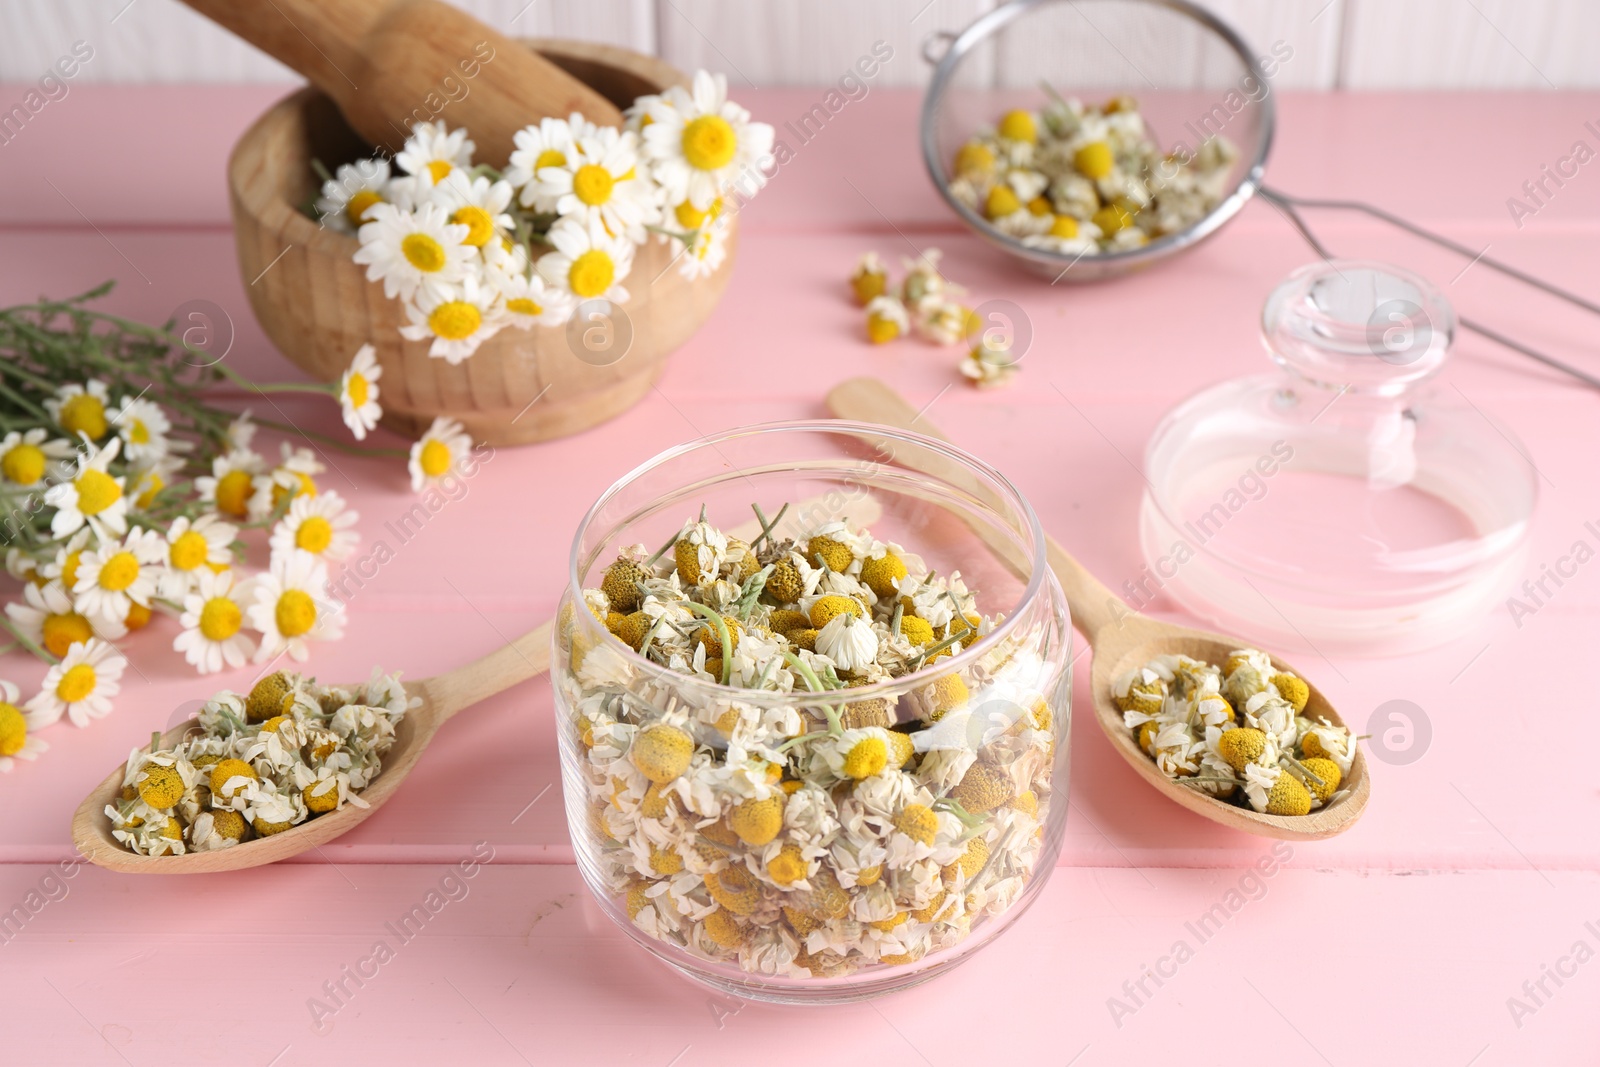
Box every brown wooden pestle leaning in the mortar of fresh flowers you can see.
[184,0,622,166]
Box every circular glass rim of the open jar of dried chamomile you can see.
[566,419,1050,707]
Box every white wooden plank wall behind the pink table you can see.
[0,0,1600,90]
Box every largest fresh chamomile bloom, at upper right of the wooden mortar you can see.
[642,70,773,211]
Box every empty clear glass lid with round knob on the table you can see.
[1122,259,1538,654]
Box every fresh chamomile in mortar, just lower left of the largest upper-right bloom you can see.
[536,126,658,242]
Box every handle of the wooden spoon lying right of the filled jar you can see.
[827,378,1136,645]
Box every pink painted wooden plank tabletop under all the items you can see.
[0,86,1600,1067]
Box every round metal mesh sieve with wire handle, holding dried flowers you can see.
[922,0,1600,387]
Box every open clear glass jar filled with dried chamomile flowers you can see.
[550,421,1072,1003]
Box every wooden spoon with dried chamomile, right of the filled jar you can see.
[827,378,1371,841]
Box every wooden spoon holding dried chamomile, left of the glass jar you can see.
[72,494,882,875]
